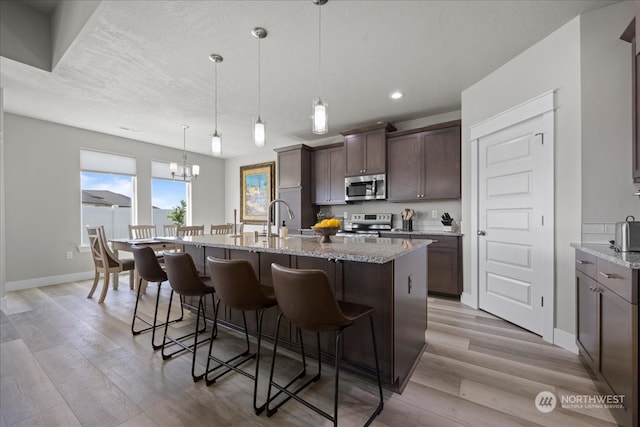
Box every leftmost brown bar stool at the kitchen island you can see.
[131,245,184,350]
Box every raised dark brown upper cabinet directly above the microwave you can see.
[342,123,396,176]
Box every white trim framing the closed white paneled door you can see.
[461,90,555,343]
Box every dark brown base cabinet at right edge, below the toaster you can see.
[576,250,640,426]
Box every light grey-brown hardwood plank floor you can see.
[0,281,615,427]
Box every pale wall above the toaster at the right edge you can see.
[580,1,640,224]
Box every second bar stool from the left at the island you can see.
[162,252,217,382]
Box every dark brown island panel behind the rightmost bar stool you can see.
[342,261,397,384]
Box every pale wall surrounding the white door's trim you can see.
[462,17,581,333]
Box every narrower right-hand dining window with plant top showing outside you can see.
[151,161,191,234]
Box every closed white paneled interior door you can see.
[477,115,554,335]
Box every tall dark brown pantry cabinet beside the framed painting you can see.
[275,145,315,233]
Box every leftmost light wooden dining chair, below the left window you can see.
[87,225,135,304]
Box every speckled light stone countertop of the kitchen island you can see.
[157,233,431,264]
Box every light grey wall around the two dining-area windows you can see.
[3,114,225,289]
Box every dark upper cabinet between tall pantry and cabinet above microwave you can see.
[311,143,346,205]
